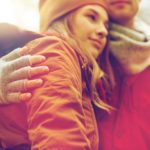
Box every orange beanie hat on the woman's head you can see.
[39,0,106,32]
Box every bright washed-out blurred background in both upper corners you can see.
[0,0,150,31]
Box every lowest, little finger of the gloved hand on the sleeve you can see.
[5,92,32,104]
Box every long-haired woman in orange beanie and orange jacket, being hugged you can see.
[0,0,112,150]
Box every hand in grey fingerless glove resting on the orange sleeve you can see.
[0,47,49,104]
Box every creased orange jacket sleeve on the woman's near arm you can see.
[27,37,90,150]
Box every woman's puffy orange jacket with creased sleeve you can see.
[0,36,99,150]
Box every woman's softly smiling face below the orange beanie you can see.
[72,5,108,58]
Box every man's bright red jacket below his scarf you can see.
[96,68,150,150]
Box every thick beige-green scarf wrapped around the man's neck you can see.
[110,18,150,74]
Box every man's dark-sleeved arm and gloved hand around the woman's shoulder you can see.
[0,23,48,104]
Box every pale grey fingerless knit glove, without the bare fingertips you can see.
[0,48,31,104]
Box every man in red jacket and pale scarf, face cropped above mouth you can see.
[96,0,150,150]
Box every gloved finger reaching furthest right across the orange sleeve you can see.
[9,66,49,81]
